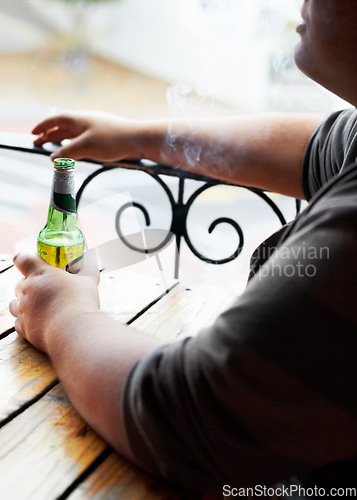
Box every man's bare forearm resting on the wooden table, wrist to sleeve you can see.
[47,311,160,460]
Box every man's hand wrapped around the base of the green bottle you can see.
[9,254,99,352]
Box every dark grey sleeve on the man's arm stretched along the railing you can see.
[303,108,357,200]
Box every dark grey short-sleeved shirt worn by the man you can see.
[123,109,357,491]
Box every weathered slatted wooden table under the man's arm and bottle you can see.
[0,256,233,500]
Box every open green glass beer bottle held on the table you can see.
[37,158,84,269]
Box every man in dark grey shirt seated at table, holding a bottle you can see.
[10,0,357,493]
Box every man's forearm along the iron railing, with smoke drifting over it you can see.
[134,114,322,198]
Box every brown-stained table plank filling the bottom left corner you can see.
[0,385,106,500]
